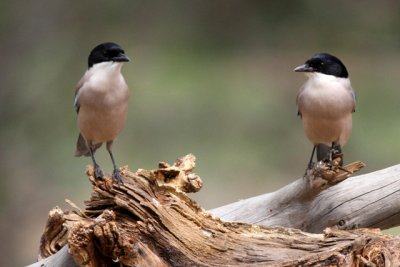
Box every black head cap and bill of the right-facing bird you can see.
[88,42,129,68]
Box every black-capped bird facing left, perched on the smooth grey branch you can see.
[294,53,356,173]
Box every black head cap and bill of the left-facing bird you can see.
[294,53,349,78]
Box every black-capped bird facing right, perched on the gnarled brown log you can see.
[74,42,130,183]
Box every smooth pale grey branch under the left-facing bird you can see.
[211,162,400,232]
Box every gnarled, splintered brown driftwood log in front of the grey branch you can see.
[31,155,400,266]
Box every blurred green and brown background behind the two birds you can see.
[0,0,400,266]
